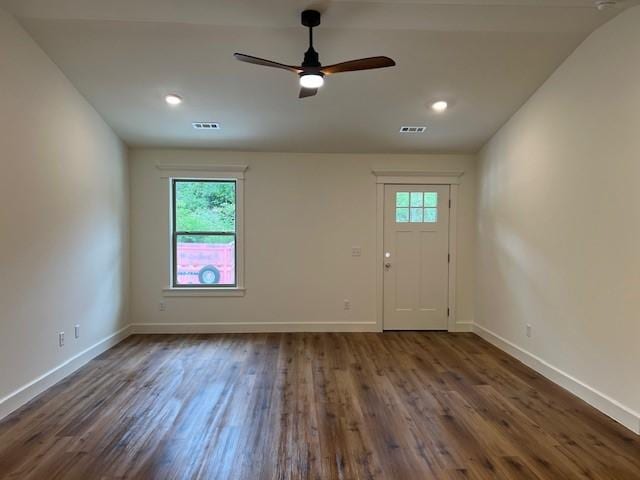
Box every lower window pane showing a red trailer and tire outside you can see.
[176,235,236,285]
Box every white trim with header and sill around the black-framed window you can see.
[156,164,248,297]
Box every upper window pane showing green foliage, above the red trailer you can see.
[175,180,236,232]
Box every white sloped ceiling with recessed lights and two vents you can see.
[0,0,635,153]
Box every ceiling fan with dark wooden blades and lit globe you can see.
[233,10,396,98]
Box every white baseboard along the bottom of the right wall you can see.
[473,324,640,435]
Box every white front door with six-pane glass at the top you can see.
[381,185,449,330]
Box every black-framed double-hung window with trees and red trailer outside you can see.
[171,179,239,288]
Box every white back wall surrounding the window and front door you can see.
[130,149,475,331]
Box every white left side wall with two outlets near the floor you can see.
[0,10,128,417]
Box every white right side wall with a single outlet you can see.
[476,7,640,431]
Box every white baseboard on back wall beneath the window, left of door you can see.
[131,322,380,334]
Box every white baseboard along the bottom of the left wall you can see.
[0,325,131,419]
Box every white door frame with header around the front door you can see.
[372,169,464,332]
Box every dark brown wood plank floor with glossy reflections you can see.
[0,333,640,480]
